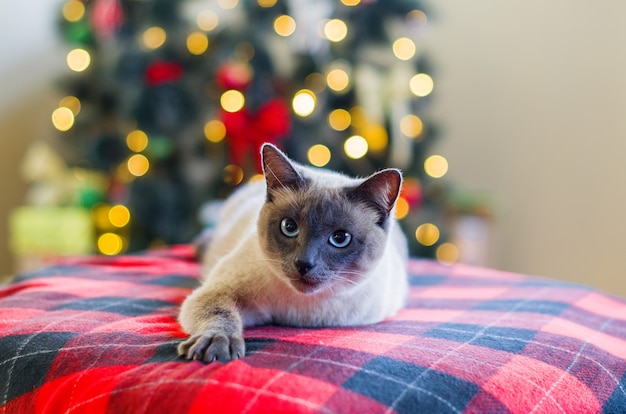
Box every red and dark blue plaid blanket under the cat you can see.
[0,246,626,413]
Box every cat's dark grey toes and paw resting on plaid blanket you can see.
[178,332,246,362]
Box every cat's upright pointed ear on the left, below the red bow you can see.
[261,143,304,195]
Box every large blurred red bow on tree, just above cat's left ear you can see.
[221,99,291,172]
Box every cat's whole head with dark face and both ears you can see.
[258,144,402,294]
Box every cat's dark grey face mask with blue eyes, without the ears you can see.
[259,186,387,294]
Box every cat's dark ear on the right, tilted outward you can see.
[350,168,402,224]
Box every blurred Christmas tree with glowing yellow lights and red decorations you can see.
[45,0,450,256]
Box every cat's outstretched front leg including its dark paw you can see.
[178,286,245,362]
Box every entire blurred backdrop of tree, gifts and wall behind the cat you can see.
[0,0,626,296]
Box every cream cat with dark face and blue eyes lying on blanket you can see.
[178,144,408,362]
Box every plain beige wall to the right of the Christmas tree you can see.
[427,0,626,296]
